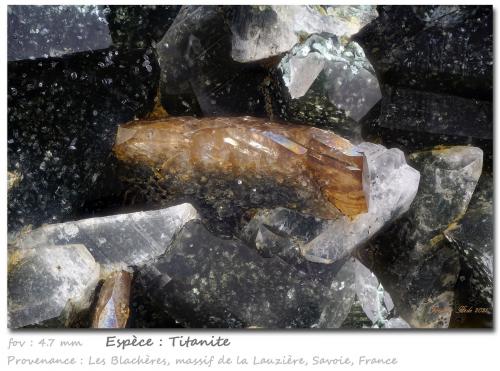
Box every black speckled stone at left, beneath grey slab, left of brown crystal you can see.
[7,49,159,230]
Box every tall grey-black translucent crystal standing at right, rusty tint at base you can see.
[360,146,483,328]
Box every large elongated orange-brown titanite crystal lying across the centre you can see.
[114,117,367,218]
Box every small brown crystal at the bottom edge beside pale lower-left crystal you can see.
[92,271,132,328]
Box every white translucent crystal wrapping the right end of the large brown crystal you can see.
[239,143,420,263]
